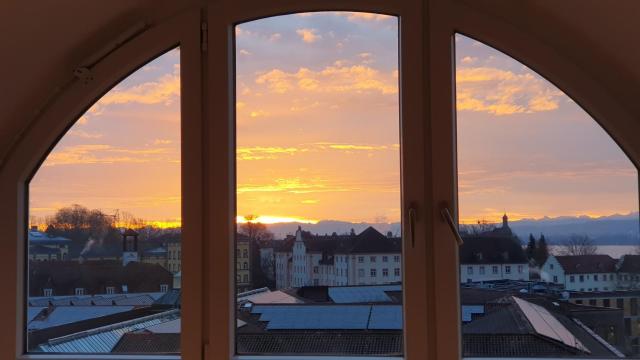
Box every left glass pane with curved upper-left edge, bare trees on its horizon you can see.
[25,49,181,354]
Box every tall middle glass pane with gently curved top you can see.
[235,12,402,355]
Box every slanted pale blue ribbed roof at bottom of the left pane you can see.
[38,310,180,353]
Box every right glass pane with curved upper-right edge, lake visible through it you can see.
[456,35,640,358]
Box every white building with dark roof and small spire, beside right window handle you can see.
[459,214,529,283]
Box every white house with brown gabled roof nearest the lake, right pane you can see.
[540,255,618,292]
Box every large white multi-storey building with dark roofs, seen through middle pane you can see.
[275,227,402,289]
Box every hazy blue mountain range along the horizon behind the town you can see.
[267,212,640,245]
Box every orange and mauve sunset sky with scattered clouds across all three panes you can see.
[30,12,638,228]
